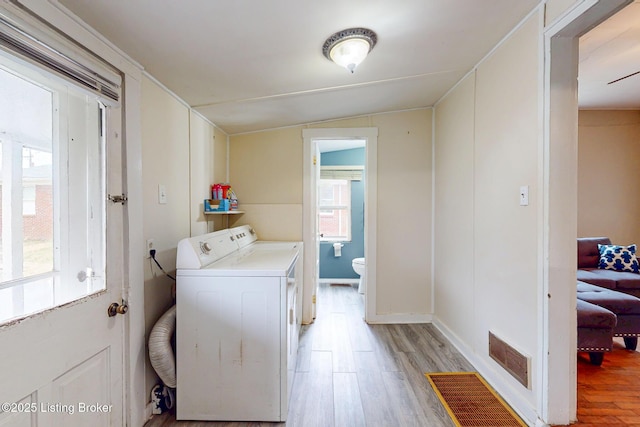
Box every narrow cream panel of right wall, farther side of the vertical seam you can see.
[434,73,476,343]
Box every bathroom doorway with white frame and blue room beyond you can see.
[302,128,378,323]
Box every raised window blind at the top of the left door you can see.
[0,10,122,102]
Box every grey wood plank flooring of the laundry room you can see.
[145,284,473,427]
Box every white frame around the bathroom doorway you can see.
[302,127,378,324]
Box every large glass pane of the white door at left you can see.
[0,59,103,322]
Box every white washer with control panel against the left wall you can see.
[176,226,303,421]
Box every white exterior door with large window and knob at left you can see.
[0,54,126,427]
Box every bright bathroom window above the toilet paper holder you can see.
[318,178,351,242]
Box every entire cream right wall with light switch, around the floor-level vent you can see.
[434,8,542,422]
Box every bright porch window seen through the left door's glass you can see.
[0,69,53,319]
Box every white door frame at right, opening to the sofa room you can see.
[537,0,631,425]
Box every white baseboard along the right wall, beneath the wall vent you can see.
[432,317,545,426]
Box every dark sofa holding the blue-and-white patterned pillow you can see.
[577,237,640,297]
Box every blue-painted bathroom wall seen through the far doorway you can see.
[319,148,365,279]
